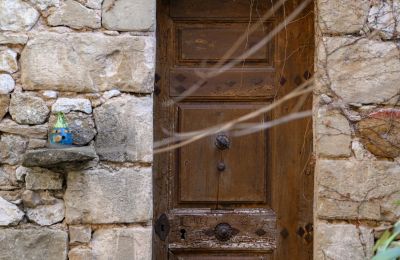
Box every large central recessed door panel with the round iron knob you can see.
[179,103,267,203]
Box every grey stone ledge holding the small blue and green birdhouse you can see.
[22,146,97,168]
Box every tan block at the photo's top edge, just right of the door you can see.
[317,0,370,34]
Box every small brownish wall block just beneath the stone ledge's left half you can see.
[25,167,63,190]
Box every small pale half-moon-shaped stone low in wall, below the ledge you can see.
[26,199,65,226]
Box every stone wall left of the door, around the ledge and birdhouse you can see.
[0,0,155,260]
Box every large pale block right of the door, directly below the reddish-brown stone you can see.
[316,160,400,221]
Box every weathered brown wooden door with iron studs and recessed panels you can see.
[153,0,314,260]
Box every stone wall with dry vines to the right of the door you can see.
[314,0,400,260]
